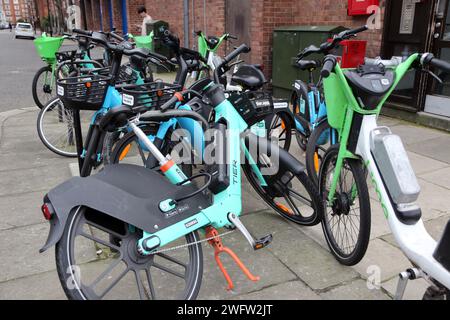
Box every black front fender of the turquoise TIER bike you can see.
[244,131,305,174]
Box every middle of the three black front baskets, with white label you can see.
[122,81,181,109]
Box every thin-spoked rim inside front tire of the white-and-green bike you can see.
[322,157,360,258]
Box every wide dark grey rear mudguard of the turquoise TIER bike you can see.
[40,164,211,252]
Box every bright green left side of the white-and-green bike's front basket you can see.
[323,73,349,131]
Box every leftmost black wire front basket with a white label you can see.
[56,74,111,110]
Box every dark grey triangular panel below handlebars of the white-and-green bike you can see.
[344,70,395,110]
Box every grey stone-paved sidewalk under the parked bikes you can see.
[0,108,450,300]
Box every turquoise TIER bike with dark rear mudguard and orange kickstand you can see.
[37,35,321,299]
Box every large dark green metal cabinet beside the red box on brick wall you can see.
[272,26,347,99]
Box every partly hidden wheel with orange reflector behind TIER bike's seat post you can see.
[109,123,193,177]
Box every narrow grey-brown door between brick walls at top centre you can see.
[225,0,252,63]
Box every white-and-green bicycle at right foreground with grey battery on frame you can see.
[319,39,450,298]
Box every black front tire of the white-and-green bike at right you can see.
[319,145,371,266]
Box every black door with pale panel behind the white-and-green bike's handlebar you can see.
[382,0,436,112]
